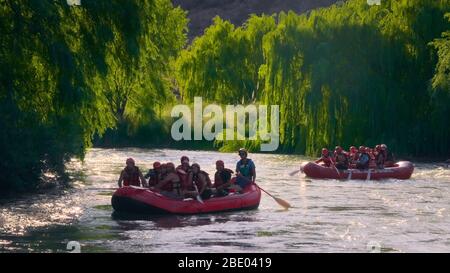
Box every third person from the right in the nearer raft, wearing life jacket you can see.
[187,163,212,199]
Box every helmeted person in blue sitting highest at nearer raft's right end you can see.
[235,148,256,192]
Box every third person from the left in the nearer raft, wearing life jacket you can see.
[150,162,184,199]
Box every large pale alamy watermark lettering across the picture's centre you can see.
[171,97,280,152]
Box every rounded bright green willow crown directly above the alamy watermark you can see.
[176,16,275,104]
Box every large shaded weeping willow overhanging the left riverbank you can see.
[0,0,186,193]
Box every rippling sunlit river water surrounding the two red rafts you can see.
[0,149,450,252]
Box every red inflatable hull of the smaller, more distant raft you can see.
[300,161,414,180]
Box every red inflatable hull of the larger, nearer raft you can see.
[111,185,261,214]
